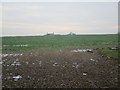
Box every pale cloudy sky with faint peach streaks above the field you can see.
[2,2,118,36]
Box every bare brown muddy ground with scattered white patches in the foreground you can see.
[2,50,119,88]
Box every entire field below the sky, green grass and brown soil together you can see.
[2,34,120,88]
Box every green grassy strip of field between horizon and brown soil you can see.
[2,35,118,52]
